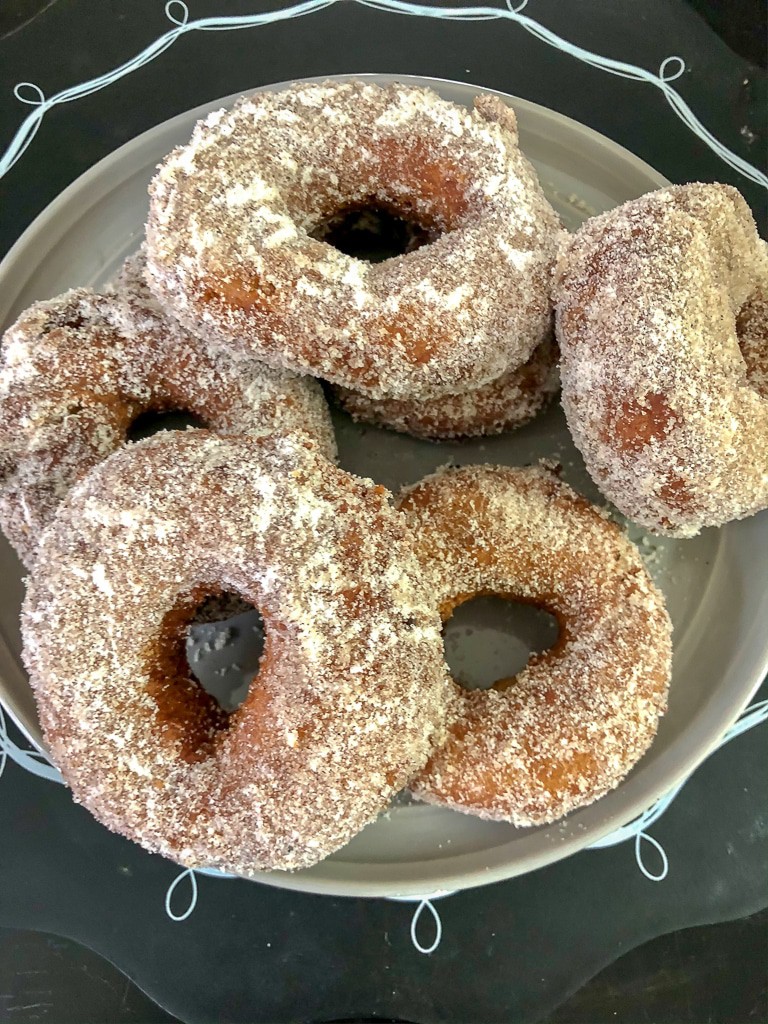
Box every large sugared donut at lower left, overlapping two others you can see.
[23,430,446,876]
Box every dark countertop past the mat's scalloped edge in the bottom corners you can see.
[6,910,768,1024]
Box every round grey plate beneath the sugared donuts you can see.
[0,75,768,896]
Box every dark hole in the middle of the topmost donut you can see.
[309,199,442,263]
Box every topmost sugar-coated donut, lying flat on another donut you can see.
[146,81,560,399]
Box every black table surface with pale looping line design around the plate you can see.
[0,0,768,1024]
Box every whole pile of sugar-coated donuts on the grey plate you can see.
[0,82,768,876]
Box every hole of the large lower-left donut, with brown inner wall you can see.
[148,588,265,762]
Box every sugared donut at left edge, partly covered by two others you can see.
[0,257,336,567]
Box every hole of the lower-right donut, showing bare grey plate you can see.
[442,595,560,690]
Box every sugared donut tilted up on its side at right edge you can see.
[555,184,768,537]
